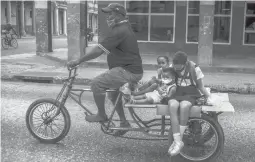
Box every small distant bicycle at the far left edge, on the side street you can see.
[1,30,18,49]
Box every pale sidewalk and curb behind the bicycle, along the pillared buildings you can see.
[1,34,255,94]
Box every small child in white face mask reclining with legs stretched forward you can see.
[130,67,176,104]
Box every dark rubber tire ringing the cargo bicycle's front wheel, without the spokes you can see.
[26,98,71,144]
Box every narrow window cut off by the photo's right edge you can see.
[244,2,255,45]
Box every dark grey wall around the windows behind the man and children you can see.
[95,1,255,57]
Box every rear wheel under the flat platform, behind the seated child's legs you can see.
[169,114,224,162]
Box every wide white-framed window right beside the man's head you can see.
[125,0,175,43]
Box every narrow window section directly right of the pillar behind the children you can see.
[213,1,232,44]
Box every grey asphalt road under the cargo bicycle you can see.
[1,82,255,162]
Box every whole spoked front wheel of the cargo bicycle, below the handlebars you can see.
[26,98,71,144]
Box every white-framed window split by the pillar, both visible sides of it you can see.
[186,1,232,44]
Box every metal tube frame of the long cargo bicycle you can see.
[48,67,170,140]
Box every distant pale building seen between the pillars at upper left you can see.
[1,0,98,36]
